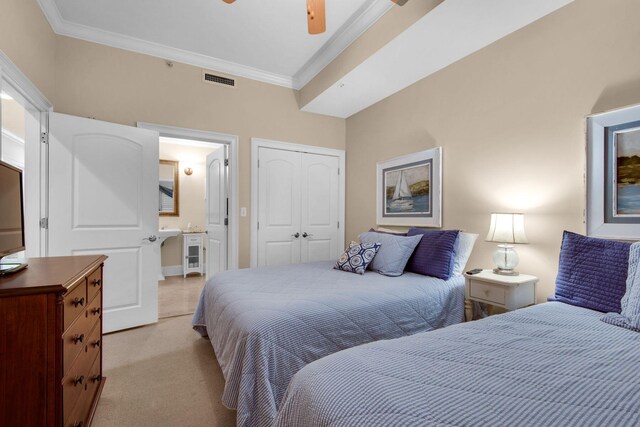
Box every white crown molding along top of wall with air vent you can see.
[37,0,293,88]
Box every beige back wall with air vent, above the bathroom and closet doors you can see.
[54,37,345,267]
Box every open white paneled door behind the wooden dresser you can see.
[49,113,160,332]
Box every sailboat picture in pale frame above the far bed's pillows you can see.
[376,147,442,227]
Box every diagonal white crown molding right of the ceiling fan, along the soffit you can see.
[293,0,394,90]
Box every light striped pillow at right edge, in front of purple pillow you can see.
[602,243,640,332]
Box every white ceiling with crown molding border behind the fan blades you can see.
[38,0,393,88]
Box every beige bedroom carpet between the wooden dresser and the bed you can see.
[93,316,235,427]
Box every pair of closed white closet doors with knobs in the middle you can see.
[257,147,342,267]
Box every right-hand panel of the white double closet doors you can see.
[300,153,342,262]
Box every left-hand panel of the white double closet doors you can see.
[258,147,301,267]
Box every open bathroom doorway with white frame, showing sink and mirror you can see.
[138,123,238,318]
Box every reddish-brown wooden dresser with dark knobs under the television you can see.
[0,255,107,427]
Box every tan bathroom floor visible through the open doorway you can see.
[158,275,205,319]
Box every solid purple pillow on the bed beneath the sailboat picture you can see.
[405,228,460,280]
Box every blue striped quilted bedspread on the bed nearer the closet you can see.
[193,262,464,426]
